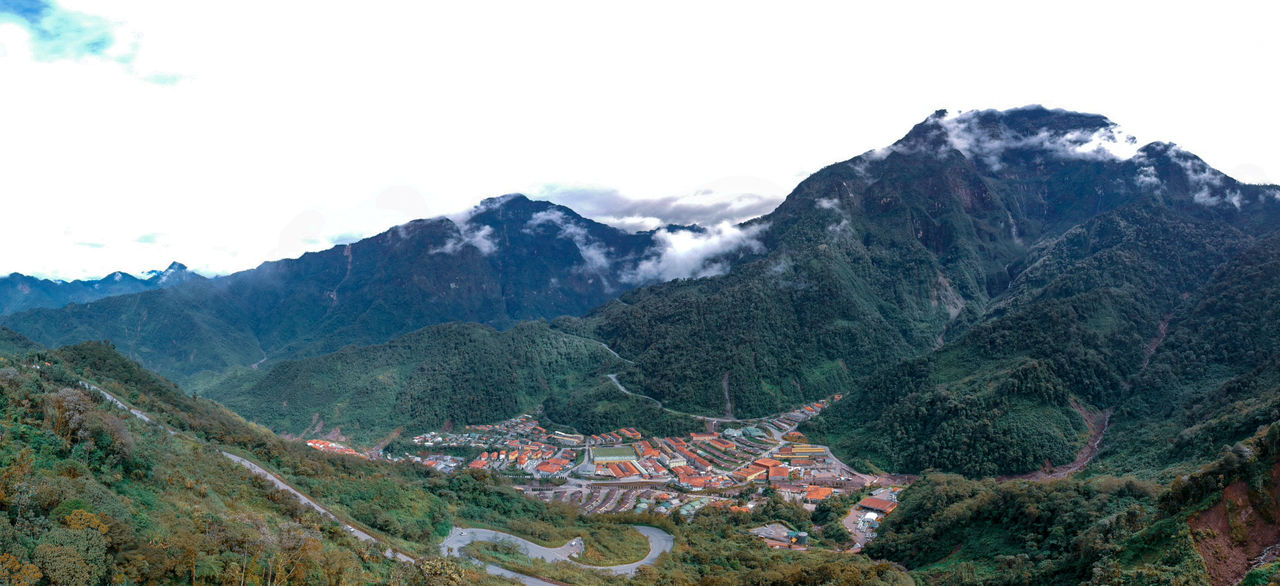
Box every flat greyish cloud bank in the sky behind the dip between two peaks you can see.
[538,184,782,232]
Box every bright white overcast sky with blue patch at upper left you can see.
[0,0,1280,279]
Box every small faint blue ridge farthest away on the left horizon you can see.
[0,262,204,315]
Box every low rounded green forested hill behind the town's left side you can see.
[207,322,701,443]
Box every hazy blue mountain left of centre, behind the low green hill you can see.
[0,194,750,380]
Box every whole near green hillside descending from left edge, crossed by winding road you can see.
[0,343,913,586]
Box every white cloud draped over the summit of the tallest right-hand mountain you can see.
[931,106,1140,170]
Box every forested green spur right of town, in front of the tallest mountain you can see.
[808,202,1249,476]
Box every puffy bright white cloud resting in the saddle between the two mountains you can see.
[622,221,768,283]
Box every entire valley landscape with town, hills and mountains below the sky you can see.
[0,106,1280,585]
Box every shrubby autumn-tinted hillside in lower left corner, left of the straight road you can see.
[0,347,488,585]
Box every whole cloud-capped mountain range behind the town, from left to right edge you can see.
[0,107,1280,476]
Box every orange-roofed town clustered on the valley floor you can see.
[307,394,910,553]
